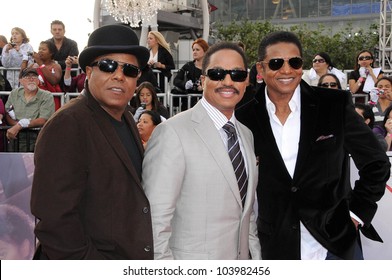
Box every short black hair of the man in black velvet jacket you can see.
[258,31,302,61]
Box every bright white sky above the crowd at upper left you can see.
[0,0,95,51]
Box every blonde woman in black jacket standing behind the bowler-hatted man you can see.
[147,31,175,92]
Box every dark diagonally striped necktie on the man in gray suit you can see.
[223,122,248,206]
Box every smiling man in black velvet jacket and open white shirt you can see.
[236,31,390,259]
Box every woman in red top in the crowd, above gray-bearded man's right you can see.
[22,40,63,111]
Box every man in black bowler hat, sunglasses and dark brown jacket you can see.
[31,25,153,259]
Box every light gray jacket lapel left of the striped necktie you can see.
[192,102,242,207]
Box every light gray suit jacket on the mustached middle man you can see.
[142,102,260,259]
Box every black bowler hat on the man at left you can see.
[79,24,150,72]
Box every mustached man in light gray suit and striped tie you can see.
[142,43,260,259]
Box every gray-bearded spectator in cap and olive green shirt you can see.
[5,68,54,152]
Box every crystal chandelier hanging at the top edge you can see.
[105,0,161,27]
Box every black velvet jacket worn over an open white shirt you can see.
[236,81,390,259]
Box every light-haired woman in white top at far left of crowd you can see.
[1,27,34,89]
